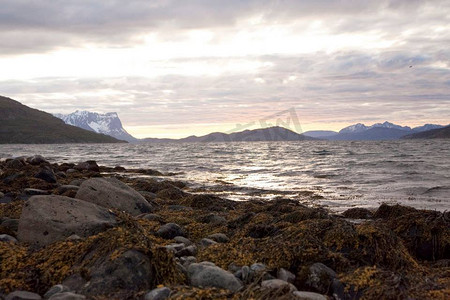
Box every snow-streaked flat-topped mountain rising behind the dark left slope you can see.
[54,110,137,142]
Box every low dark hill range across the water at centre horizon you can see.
[141,126,314,143]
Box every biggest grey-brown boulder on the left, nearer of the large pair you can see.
[17,195,117,246]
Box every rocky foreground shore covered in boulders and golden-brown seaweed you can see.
[0,155,450,300]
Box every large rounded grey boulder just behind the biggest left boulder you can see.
[75,178,152,216]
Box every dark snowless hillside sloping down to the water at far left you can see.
[0,96,123,144]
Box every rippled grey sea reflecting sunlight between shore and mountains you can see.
[0,140,450,212]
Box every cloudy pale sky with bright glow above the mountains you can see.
[0,0,450,138]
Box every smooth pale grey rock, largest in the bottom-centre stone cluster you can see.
[188,262,242,292]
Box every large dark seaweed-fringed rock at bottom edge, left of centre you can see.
[80,250,155,298]
